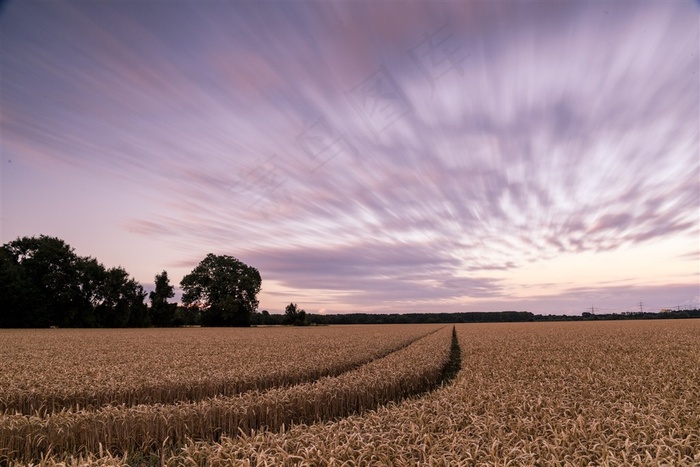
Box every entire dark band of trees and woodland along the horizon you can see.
[0,235,700,328]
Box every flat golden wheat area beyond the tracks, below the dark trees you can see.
[0,325,438,416]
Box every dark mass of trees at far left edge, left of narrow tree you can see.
[0,235,149,327]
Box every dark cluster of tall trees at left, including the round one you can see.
[0,235,261,328]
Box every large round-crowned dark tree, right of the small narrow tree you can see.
[180,253,262,326]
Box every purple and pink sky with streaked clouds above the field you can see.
[0,0,700,314]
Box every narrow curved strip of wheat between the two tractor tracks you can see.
[0,327,457,462]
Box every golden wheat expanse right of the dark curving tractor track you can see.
[167,320,700,466]
